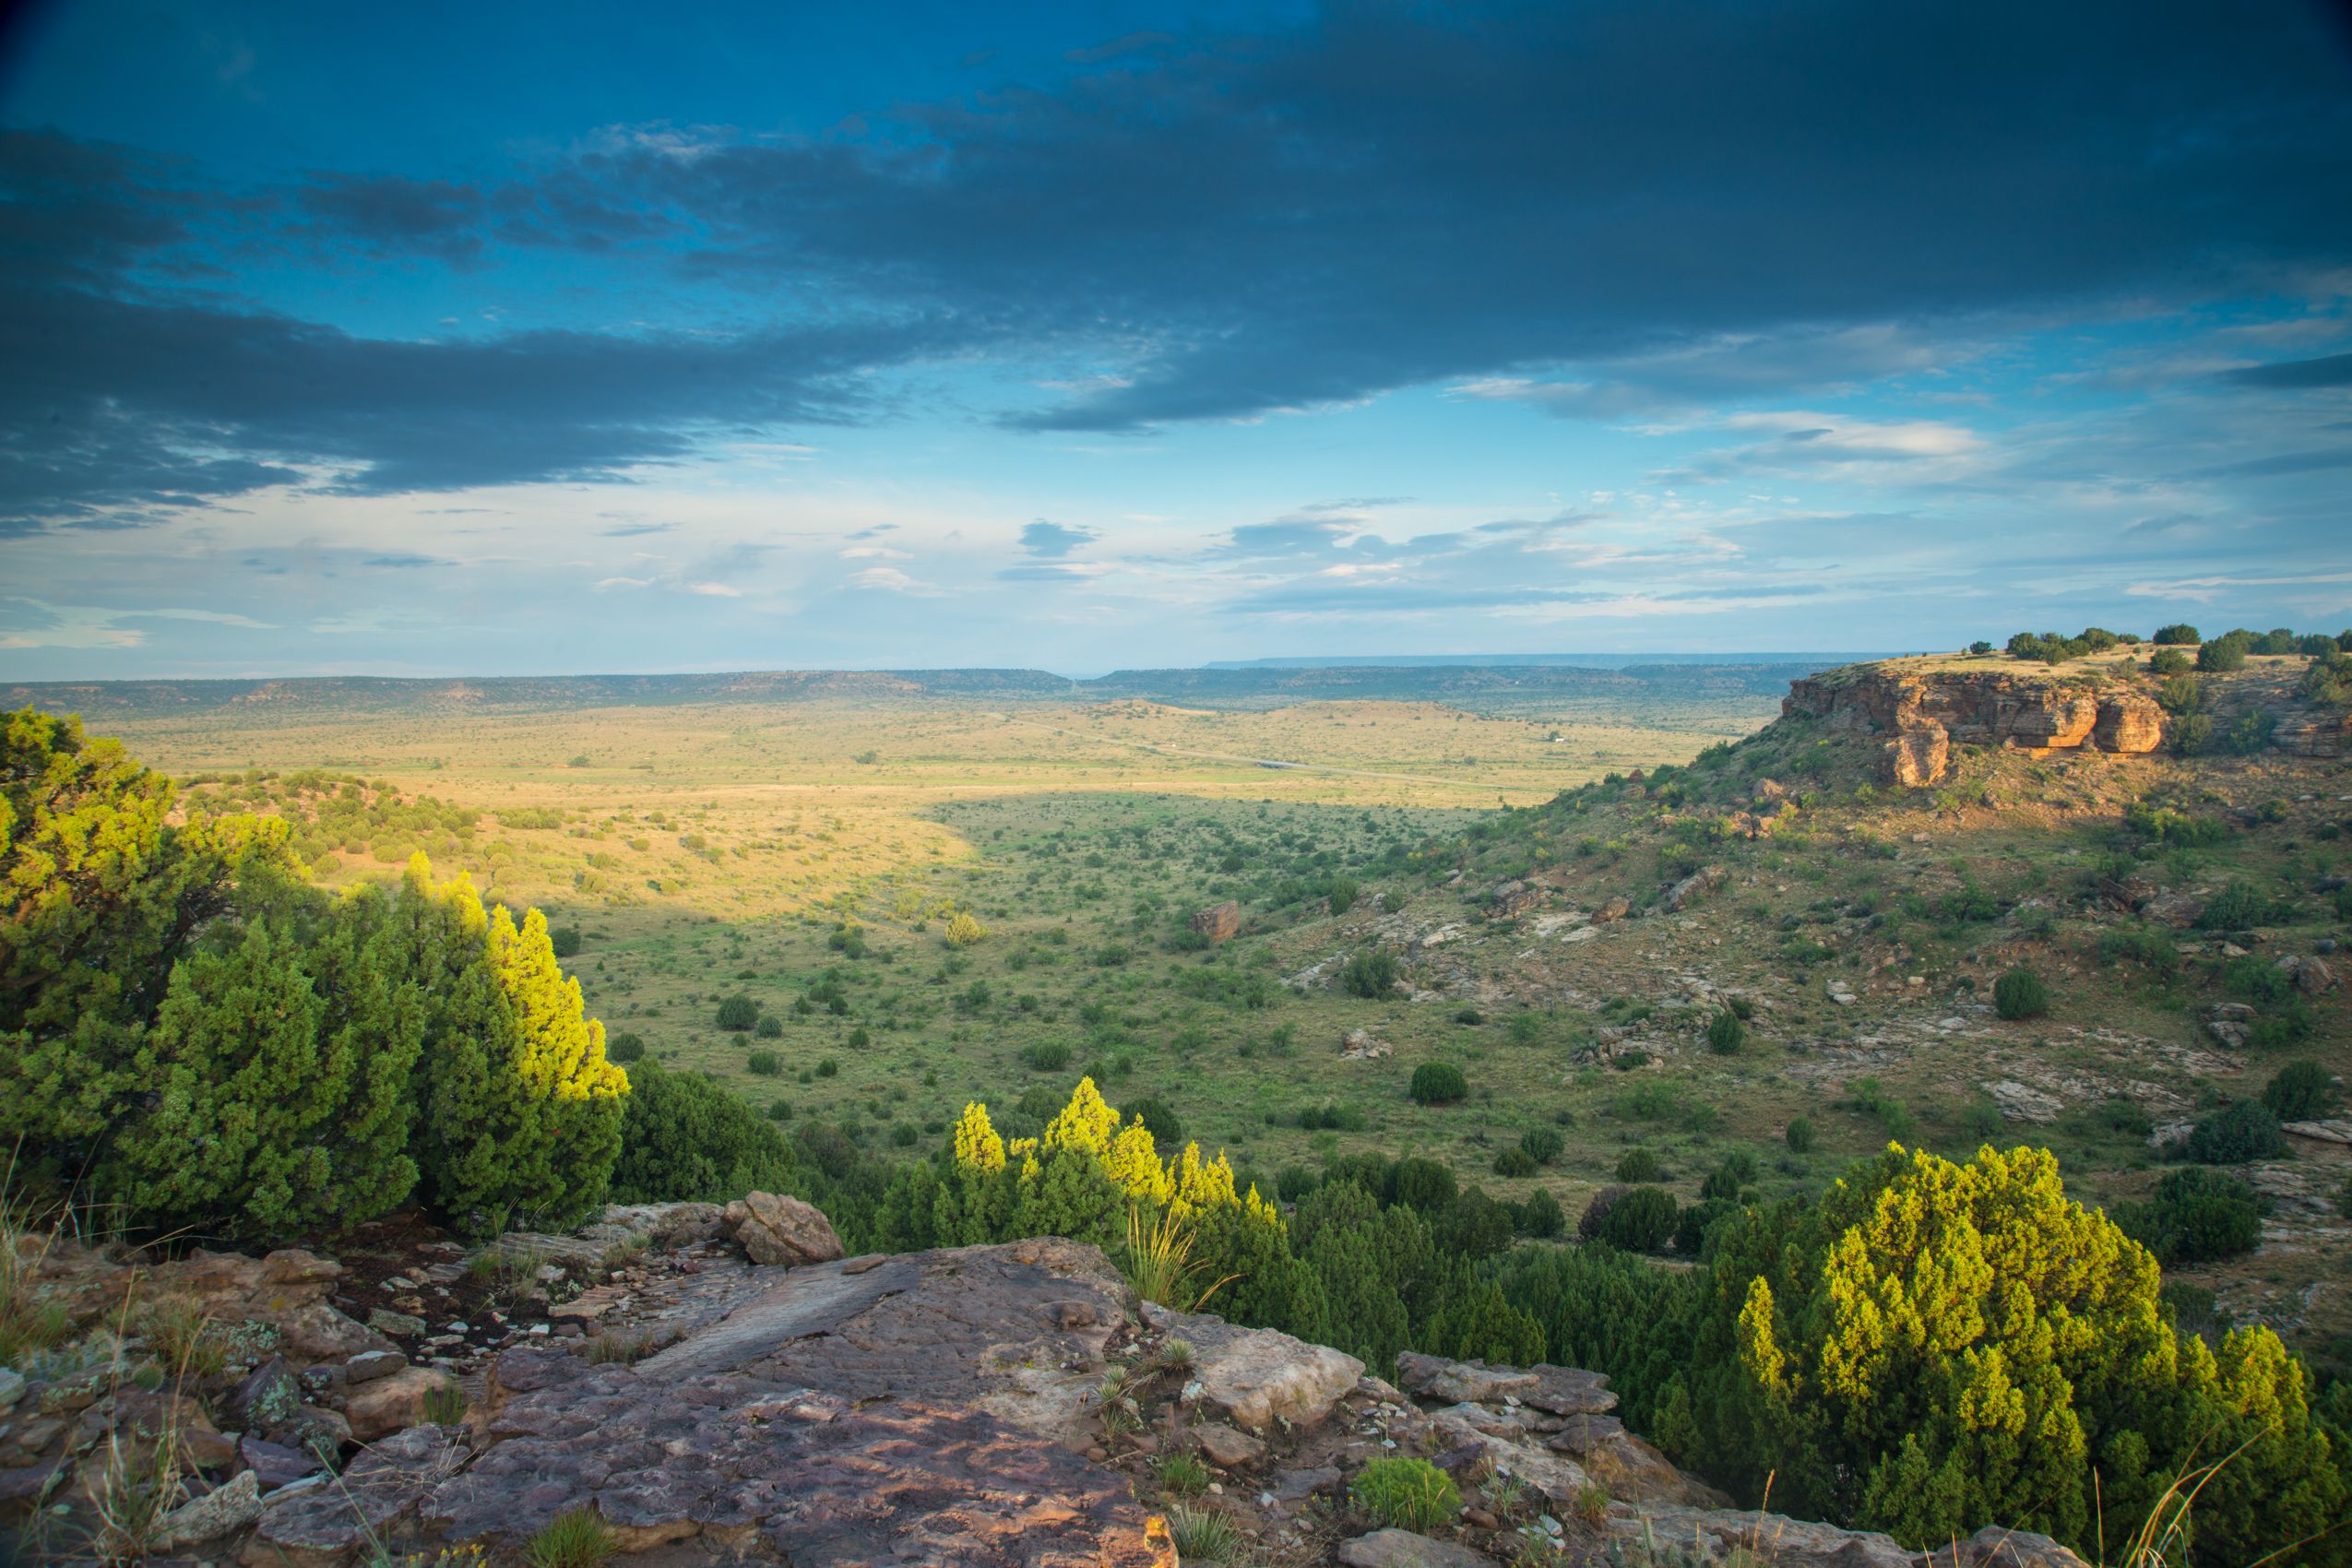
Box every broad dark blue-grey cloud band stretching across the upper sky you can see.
[0,0,2352,531]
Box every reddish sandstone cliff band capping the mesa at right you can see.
[1780,665,2164,785]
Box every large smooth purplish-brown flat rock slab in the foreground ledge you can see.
[324,1239,1176,1568]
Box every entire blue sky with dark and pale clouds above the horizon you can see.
[0,0,2352,680]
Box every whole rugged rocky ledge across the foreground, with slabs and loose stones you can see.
[0,1199,2079,1568]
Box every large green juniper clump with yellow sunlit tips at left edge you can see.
[0,710,628,1239]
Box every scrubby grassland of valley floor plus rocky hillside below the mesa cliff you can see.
[64,654,2352,1363]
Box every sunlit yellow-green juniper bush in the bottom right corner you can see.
[1654,1149,2345,1563]
